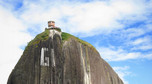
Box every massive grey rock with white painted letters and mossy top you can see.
[7,29,123,84]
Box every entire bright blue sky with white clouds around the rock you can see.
[0,0,152,84]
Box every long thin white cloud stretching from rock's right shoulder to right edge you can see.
[97,46,152,61]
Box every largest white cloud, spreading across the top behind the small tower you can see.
[17,0,150,37]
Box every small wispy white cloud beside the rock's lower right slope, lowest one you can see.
[112,66,131,84]
